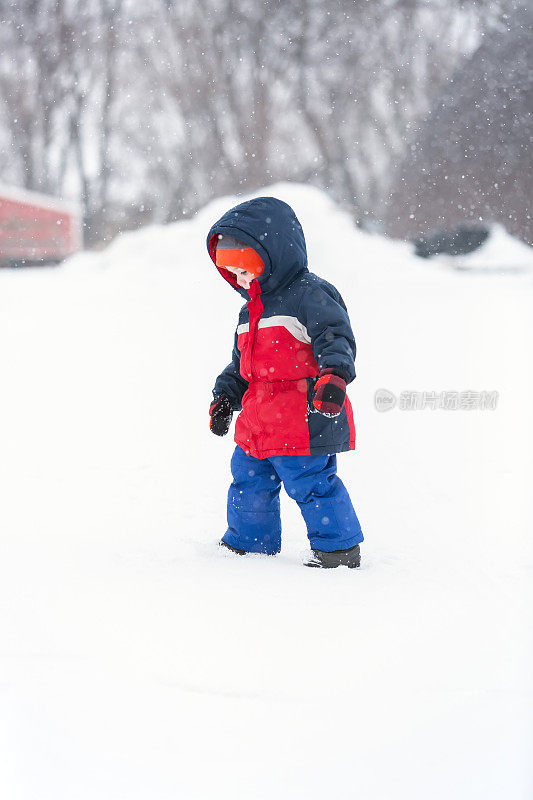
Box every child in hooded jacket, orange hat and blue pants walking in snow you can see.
[207,197,363,568]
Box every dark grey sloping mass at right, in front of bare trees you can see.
[384,7,533,244]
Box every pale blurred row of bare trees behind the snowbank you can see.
[0,0,524,241]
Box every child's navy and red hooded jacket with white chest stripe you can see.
[207,197,355,458]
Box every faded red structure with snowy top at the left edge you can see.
[0,183,82,267]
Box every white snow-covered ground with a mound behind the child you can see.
[0,185,533,800]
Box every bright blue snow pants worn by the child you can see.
[223,445,363,553]
